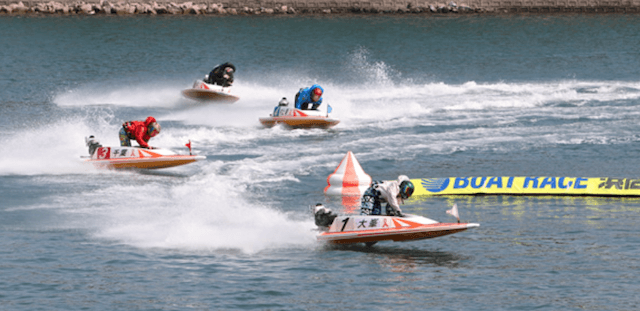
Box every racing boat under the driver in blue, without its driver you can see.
[260,98,340,129]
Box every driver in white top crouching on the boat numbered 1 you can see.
[360,175,414,217]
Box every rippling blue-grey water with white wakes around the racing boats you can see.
[0,14,640,310]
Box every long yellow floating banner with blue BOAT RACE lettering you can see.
[411,176,640,196]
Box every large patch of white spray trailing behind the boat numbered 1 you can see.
[63,165,315,253]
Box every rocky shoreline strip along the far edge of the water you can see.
[0,0,640,16]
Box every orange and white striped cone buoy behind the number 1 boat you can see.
[324,151,371,197]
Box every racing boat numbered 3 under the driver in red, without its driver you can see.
[85,137,206,169]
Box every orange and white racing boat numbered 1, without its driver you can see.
[314,205,480,246]
